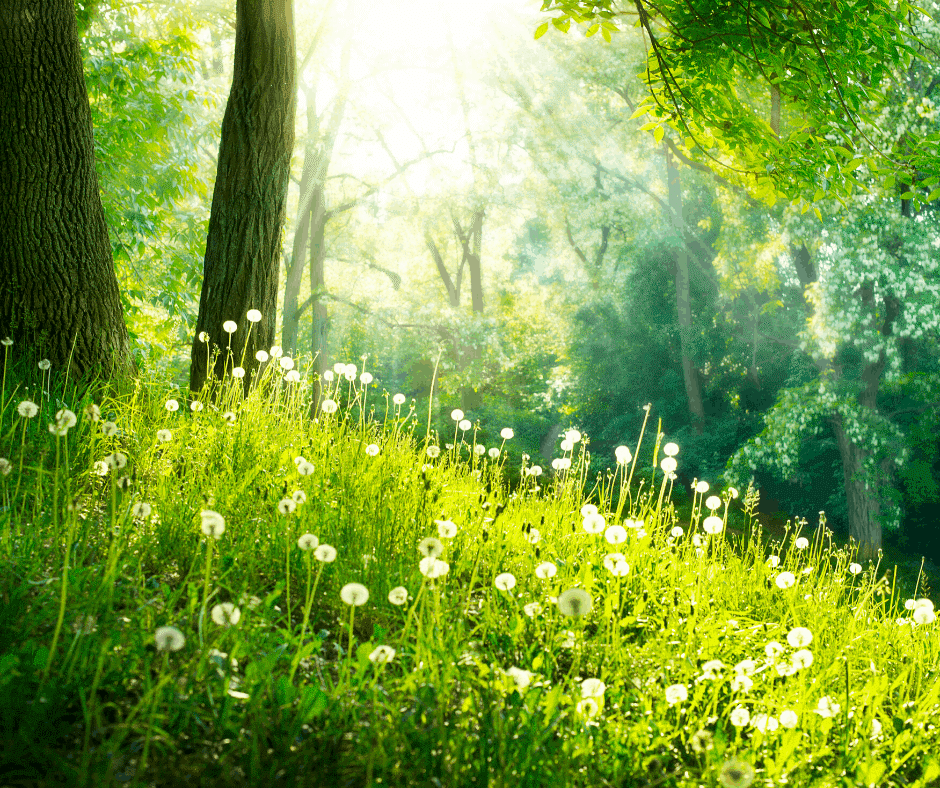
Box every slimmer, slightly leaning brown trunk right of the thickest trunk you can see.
[189,0,295,392]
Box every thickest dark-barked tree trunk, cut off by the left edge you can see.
[0,0,133,376]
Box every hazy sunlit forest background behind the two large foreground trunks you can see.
[5,0,940,576]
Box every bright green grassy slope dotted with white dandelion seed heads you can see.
[0,344,940,788]
